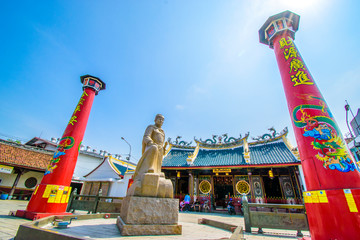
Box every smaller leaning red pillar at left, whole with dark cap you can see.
[16,75,105,219]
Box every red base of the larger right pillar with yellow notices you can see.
[304,188,360,240]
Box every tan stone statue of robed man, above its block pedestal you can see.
[127,114,173,198]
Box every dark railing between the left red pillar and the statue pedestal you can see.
[66,191,123,213]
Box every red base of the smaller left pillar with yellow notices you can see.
[16,184,71,219]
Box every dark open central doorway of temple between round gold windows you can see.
[214,176,234,209]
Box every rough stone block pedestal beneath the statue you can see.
[116,196,182,236]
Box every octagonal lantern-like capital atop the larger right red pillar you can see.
[259,11,300,48]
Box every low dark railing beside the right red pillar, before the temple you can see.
[242,197,309,237]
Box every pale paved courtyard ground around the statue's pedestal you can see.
[0,200,309,240]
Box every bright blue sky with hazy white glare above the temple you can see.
[0,0,360,161]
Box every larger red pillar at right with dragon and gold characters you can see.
[259,11,360,240]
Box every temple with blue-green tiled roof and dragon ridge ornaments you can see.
[162,128,305,208]
